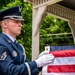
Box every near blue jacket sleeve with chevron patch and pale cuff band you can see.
[0,45,39,75]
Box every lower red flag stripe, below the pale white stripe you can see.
[47,65,75,73]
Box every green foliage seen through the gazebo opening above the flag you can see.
[40,15,74,51]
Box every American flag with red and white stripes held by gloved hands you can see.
[42,46,75,75]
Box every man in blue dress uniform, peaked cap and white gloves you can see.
[0,6,54,75]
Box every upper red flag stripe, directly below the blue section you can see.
[49,49,75,57]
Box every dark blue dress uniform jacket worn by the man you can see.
[0,33,39,75]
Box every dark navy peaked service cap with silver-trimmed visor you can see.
[0,6,24,21]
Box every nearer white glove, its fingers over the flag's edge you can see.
[35,54,54,67]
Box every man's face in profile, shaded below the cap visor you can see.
[1,19,22,37]
